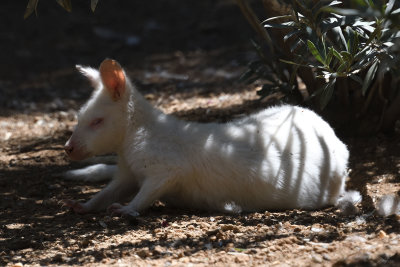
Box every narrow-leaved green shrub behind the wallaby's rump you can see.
[237,0,400,134]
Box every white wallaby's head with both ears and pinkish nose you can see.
[64,59,130,160]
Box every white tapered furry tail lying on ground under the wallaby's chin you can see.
[62,164,117,182]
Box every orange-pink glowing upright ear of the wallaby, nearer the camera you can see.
[99,59,126,101]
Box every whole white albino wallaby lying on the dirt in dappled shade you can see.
[64,59,360,216]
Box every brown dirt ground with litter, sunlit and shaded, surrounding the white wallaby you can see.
[0,0,400,266]
